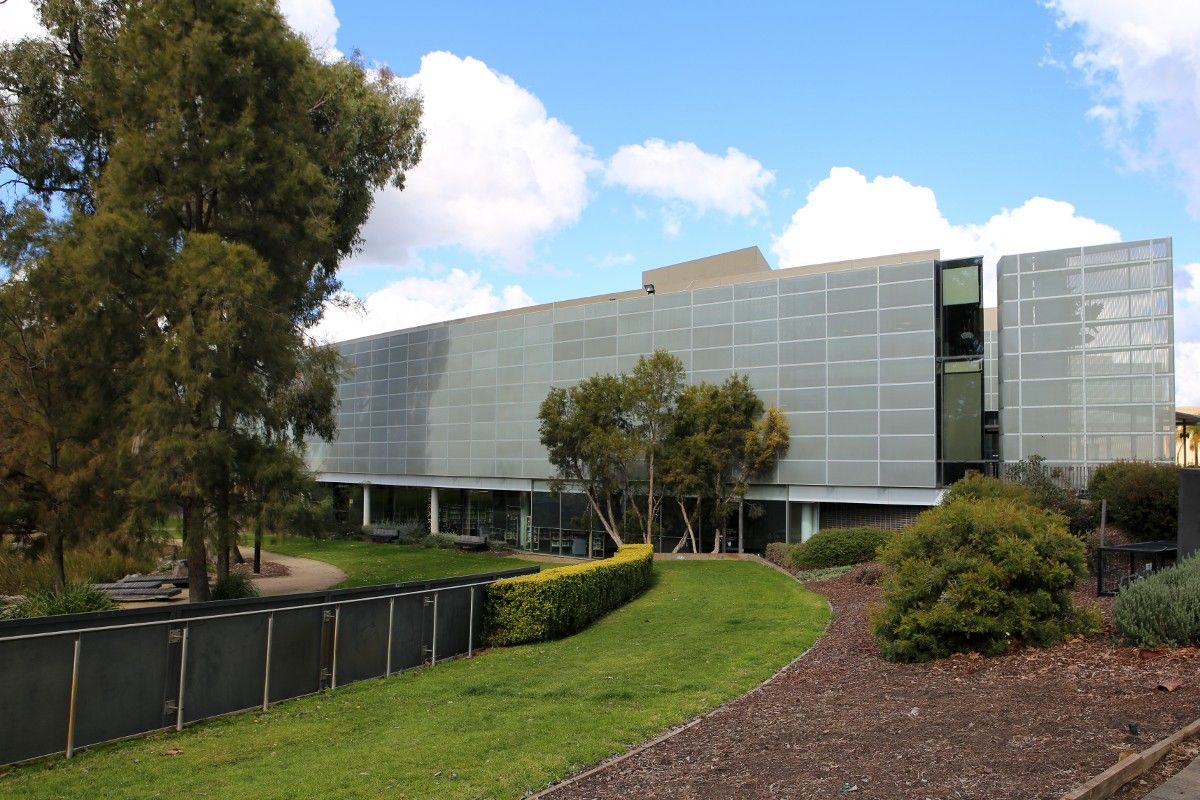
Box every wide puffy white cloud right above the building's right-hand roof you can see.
[772,167,1121,305]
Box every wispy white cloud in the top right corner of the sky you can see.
[1046,0,1200,217]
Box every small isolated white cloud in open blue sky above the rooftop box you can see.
[605,139,775,217]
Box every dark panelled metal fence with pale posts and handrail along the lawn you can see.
[0,567,536,764]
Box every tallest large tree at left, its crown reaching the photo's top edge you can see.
[0,0,422,600]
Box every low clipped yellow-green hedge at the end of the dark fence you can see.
[484,545,654,646]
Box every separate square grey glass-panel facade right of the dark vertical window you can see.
[998,239,1175,470]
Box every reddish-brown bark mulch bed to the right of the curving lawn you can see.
[551,572,1200,800]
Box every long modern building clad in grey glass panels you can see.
[308,239,1175,555]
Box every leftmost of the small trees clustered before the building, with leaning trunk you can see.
[538,375,641,545]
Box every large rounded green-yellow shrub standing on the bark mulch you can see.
[871,498,1098,661]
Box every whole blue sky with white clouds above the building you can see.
[0,0,1200,404]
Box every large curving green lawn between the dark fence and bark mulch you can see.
[0,563,828,800]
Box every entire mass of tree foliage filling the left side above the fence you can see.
[0,0,422,600]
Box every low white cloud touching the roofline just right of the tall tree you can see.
[312,269,534,342]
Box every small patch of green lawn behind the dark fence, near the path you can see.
[261,536,536,589]
